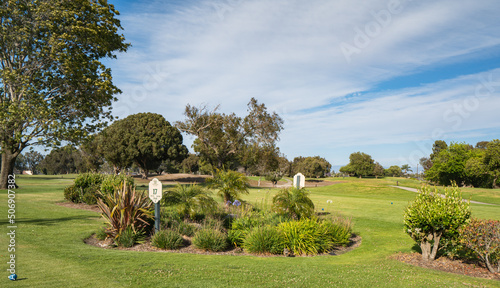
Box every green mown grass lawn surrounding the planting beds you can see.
[0,175,500,287]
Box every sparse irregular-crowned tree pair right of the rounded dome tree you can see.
[176,98,283,169]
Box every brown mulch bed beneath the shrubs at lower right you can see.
[391,252,500,280]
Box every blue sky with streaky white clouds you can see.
[105,0,500,172]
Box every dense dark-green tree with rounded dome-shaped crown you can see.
[102,113,188,179]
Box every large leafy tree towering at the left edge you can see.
[0,0,129,189]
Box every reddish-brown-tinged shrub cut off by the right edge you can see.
[460,219,500,273]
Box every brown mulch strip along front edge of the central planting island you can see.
[83,234,361,257]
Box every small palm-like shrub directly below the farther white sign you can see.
[273,188,314,219]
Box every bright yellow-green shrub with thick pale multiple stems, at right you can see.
[404,185,471,261]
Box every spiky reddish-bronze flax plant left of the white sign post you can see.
[97,185,153,240]
